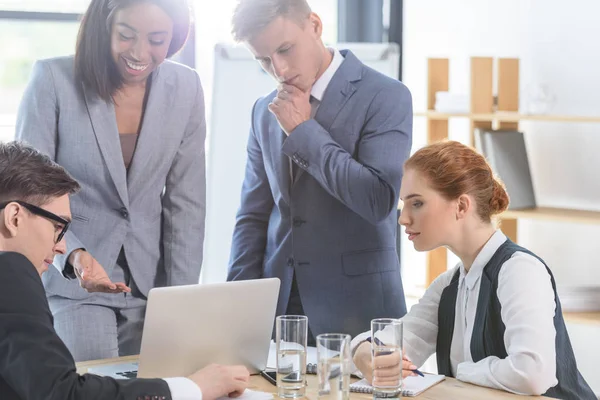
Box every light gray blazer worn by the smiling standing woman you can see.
[16,57,206,299]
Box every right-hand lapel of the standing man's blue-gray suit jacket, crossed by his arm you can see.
[294,50,363,184]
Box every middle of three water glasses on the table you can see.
[316,333,352,400]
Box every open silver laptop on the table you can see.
[88,278,280,379]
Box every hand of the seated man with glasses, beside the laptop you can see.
[188,364,250,400]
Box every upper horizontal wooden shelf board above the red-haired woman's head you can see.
[414,111,600,123]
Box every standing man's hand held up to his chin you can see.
[269,83,311,136]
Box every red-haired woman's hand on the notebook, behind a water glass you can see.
[353,342,417,386]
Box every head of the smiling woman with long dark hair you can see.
[75,0,190,100]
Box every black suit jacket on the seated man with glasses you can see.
[0,252,171,400]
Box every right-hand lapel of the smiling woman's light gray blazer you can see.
[127,67,175,192]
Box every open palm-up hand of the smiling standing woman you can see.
[69,249,131,293]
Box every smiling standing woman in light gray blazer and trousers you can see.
[16,0,206,361]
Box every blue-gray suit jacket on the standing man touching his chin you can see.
[228,51,412,335]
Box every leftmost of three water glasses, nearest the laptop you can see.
[275,315,308,398]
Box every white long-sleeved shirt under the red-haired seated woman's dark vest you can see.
[352,230,558,395]
